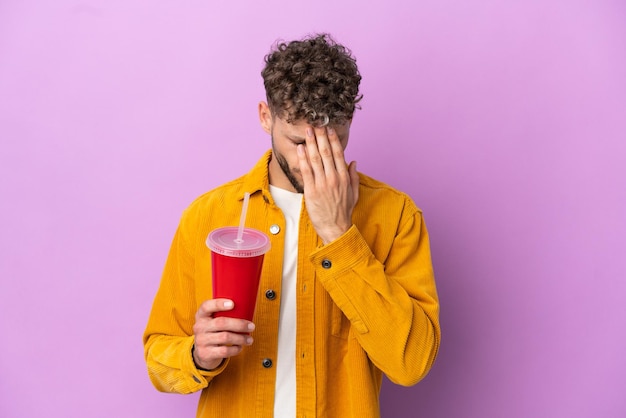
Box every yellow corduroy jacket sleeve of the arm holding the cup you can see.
[143,217,228,393]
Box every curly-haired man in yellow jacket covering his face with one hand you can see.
[143,35,440,418]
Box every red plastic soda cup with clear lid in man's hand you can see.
[206,226,270,321]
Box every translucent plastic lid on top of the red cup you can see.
[206,226,270,257]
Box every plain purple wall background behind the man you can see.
[0,0,626,418]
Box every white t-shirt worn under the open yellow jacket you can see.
[270,185,302,418]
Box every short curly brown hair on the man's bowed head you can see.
[261,34,363,126]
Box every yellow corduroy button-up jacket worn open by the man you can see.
[143,152,440,418]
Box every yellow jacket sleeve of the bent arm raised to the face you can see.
[310,201,441,386]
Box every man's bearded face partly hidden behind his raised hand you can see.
[259,103,350,193]
